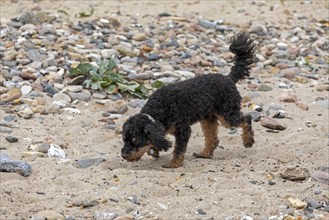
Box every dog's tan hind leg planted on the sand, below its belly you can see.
[193,116,219,158]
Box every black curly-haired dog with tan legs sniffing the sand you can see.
[121,33,255,168]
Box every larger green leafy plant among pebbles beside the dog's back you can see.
[69,59,163,99]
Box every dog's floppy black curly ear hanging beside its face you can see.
[145,122,171,151]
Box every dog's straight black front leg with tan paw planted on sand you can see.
[163,126,191,168]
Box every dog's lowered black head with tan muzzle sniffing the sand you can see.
[121,114,171,161]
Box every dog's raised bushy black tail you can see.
[229,32,256,82]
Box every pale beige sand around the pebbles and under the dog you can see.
[0,0,329,219]
